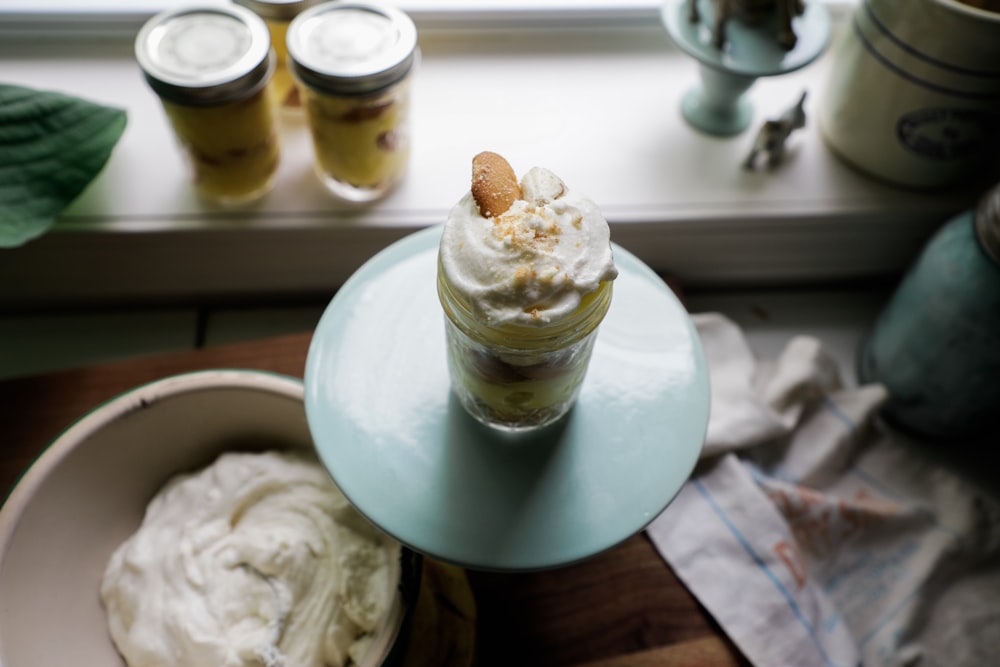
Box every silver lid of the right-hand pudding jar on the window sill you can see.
[287,0,417,95]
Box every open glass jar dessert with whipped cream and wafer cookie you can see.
[437,153,617,431]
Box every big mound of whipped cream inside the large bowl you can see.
[101,451,400,667]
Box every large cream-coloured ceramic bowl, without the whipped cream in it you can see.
[0,370,416,667]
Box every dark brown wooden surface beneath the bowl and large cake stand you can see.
[0,333,748,667]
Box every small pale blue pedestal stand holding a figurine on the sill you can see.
[662,0,830,136]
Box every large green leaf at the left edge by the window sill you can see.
[0,84,126,248]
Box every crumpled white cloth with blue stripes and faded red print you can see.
[647,314,1000,667]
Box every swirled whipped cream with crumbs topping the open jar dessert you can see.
[439,167,618,326]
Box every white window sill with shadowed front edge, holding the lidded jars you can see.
[0,10,973,308]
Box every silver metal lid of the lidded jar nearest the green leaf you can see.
[135,5,274,106]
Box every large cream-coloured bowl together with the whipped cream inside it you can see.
[0,370,421,667]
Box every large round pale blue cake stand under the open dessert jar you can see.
[305,225,710,571]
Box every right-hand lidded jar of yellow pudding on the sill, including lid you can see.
[288,0,418,202]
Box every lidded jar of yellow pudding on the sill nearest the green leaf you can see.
[135,5,279,204]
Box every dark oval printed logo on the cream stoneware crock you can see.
[896,109,1000,160]
